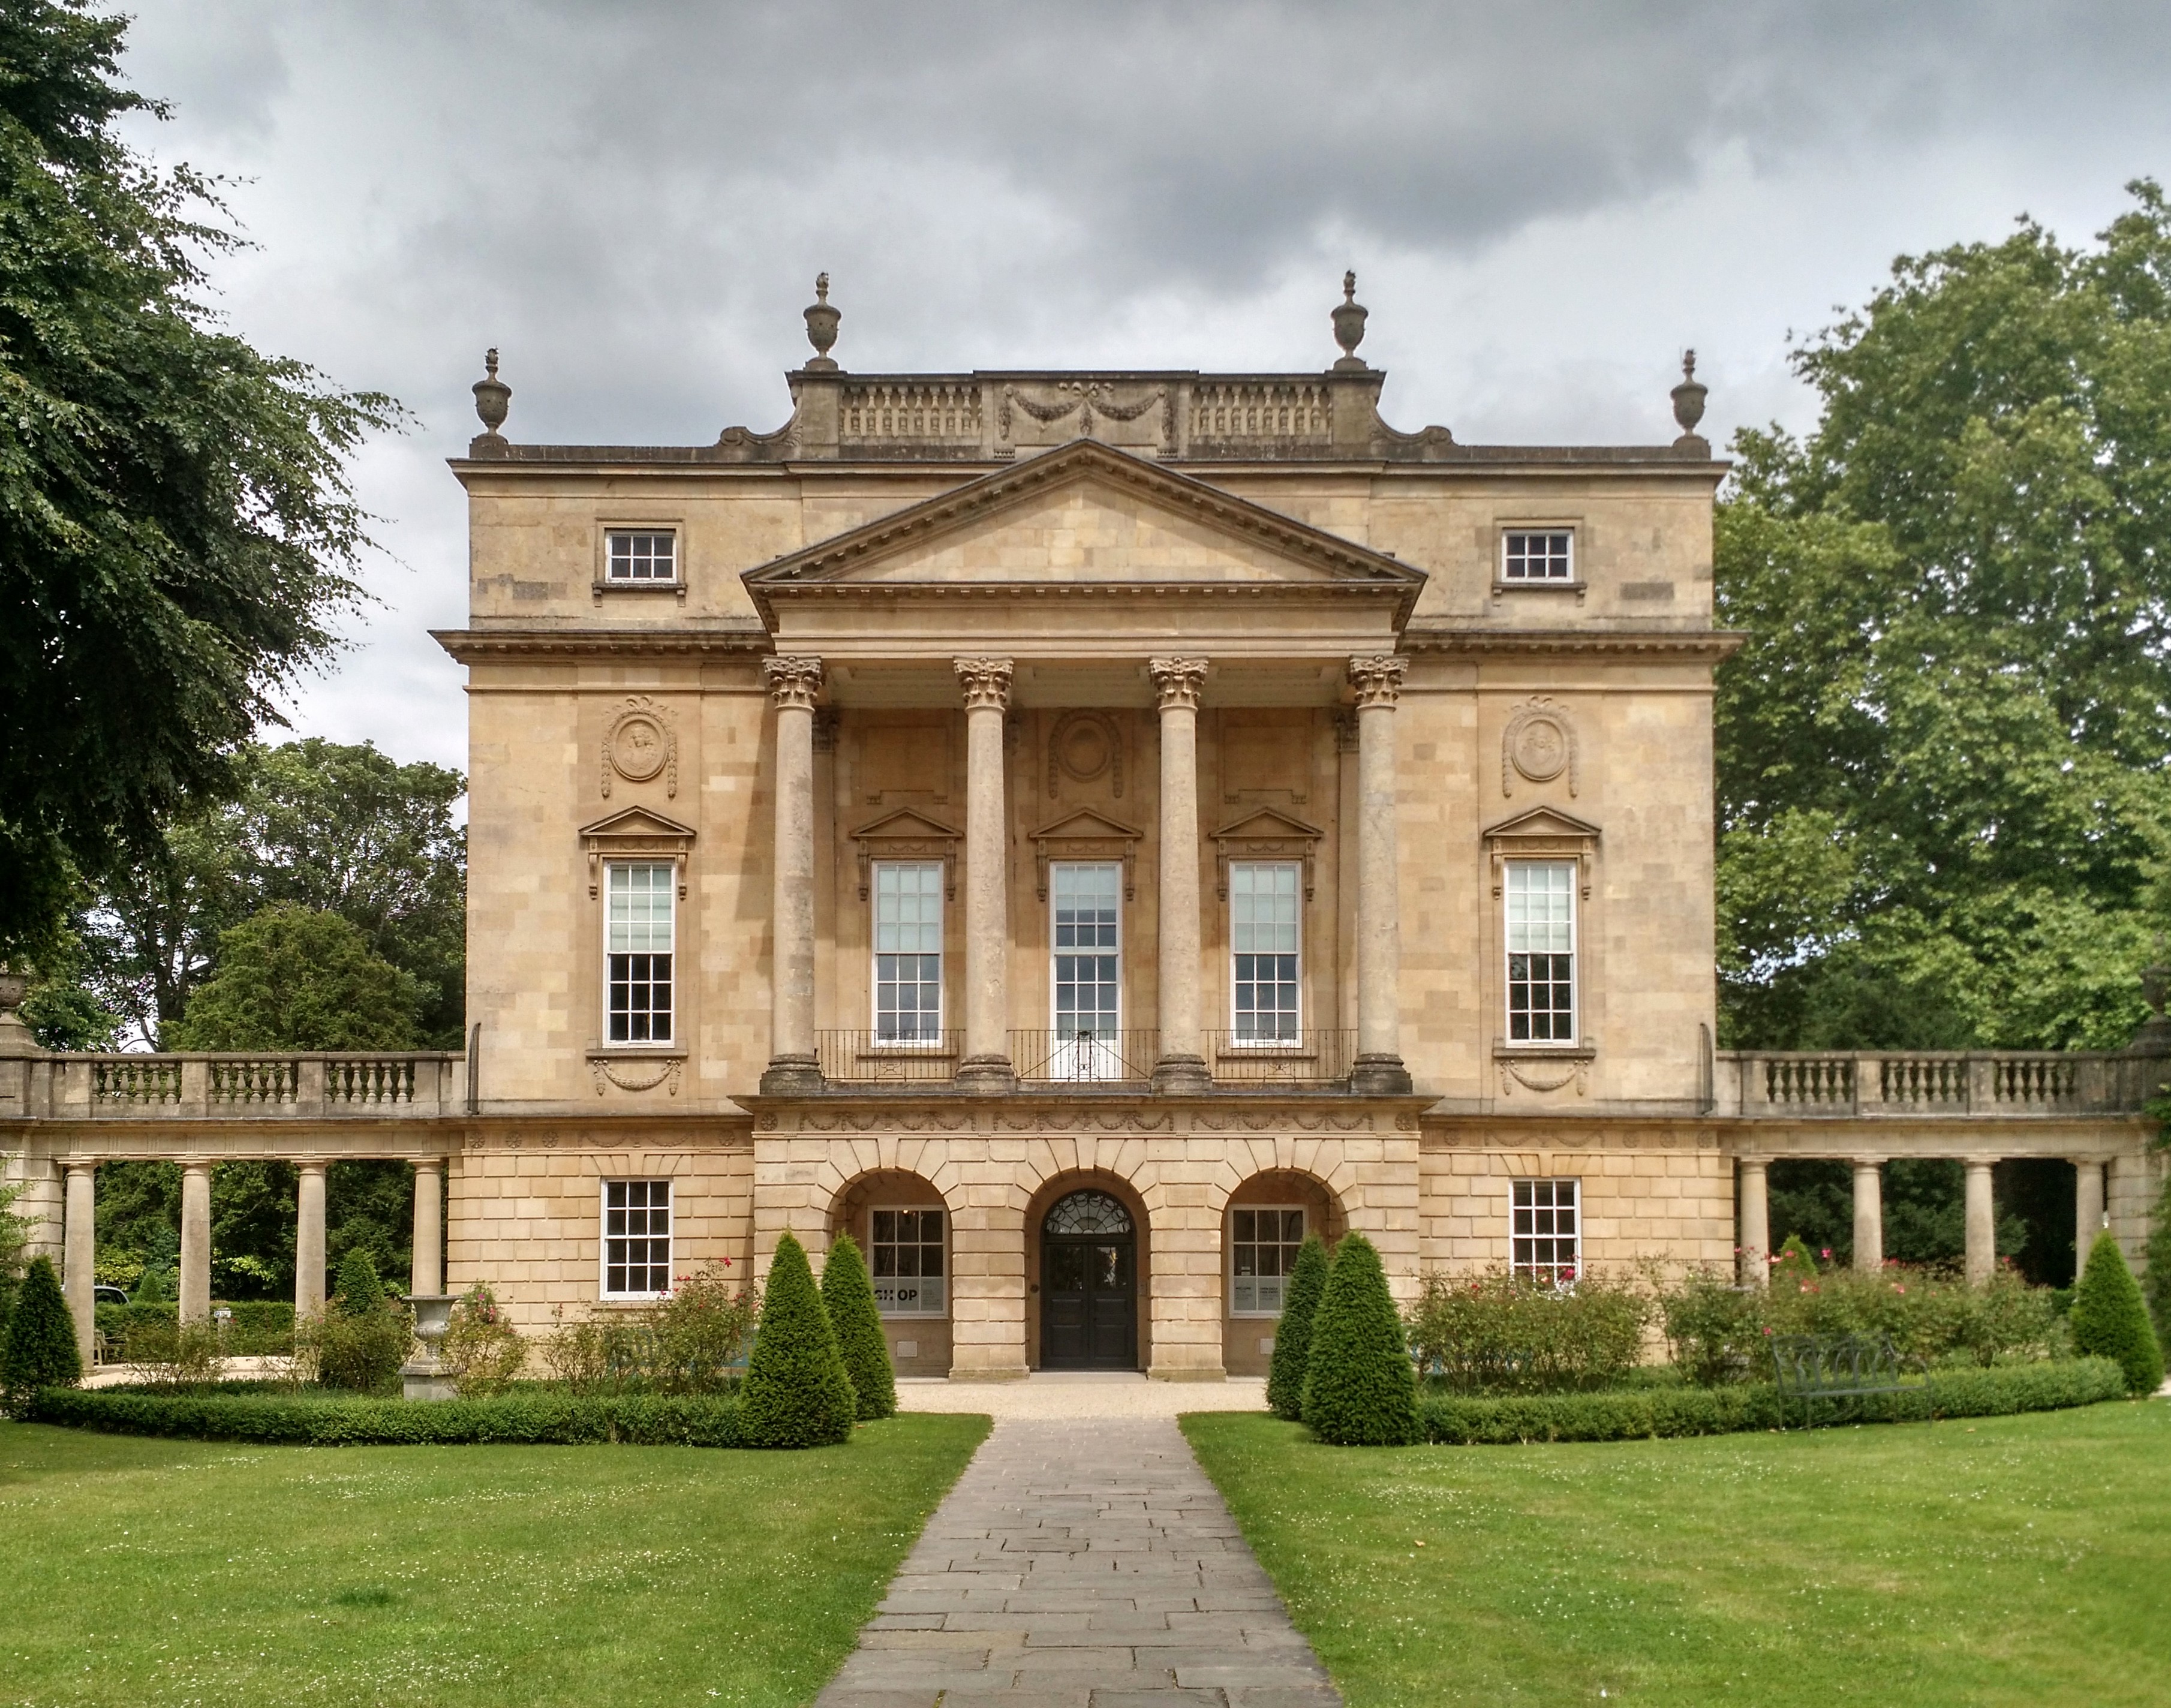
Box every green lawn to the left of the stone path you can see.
[0,1415,988,1708]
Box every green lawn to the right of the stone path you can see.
[1183,1402,2171,1708]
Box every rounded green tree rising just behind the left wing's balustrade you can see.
[158,903,419,1051]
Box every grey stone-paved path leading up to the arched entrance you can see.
[816,1417,1342,1708]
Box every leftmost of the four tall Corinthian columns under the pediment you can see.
[762,655,820,1096]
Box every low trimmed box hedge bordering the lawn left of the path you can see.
[24,1387,745,1448]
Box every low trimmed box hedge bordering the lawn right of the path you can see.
[1418,1358,2125,1448]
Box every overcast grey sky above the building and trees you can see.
[114,0,2171,766]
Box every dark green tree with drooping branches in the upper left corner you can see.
[0,0,397,953]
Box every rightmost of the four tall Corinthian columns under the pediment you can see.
[1351,653,1411,1096]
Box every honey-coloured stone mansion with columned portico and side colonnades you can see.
[0,279,2160,1378]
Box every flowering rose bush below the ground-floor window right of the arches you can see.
[1409,1270,1652,1393]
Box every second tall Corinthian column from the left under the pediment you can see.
[955,657,1018,1091]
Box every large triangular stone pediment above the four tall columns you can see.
[745,441,1424,621]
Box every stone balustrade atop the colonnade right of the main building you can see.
[1711,1051,2171,1120]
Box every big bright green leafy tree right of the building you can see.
[1715,182,2171,1048]
